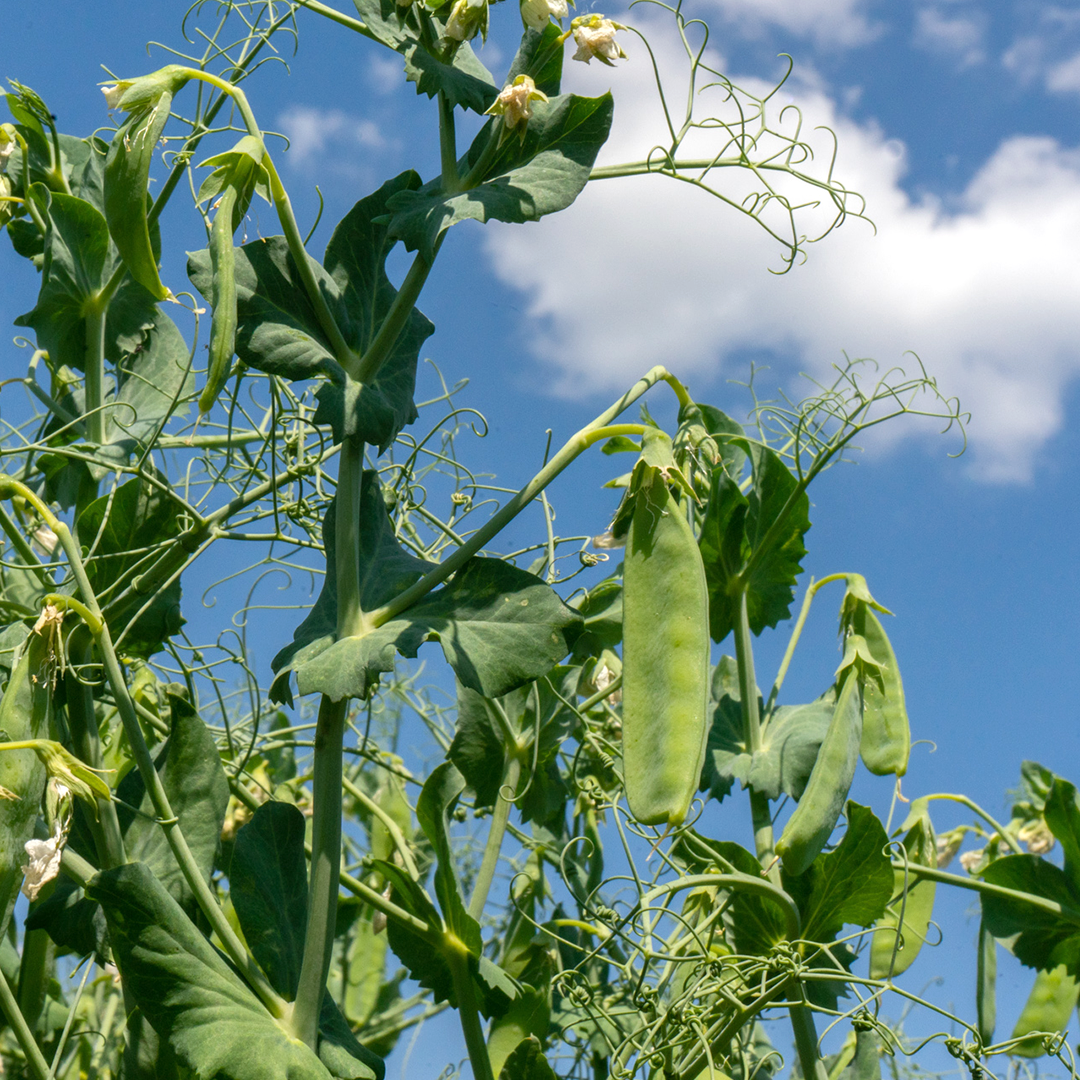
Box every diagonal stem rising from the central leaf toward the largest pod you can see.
[369,366,671,626]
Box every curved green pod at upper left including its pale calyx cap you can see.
[105,65,189,300]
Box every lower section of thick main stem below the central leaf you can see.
[293,697,349,1050]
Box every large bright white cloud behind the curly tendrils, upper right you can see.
[484,34,1080,481]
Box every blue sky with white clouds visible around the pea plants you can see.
[6,0,1080,1071]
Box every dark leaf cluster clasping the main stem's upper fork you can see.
[188,172,434,449]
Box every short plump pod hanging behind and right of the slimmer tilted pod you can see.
[852,604,912,777]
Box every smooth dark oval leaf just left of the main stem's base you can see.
[229,802,308,1001]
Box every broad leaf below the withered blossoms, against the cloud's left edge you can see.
[387,94,612,257]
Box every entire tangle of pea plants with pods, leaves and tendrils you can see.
[0,0,1080,1080]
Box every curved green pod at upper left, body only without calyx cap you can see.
[105,90,173,300]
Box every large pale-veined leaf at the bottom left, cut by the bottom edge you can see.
[86,863,330,1080]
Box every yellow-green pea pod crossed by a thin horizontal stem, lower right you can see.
[863,812,937,978]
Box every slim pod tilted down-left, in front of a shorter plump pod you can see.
[777,665,863,876]
